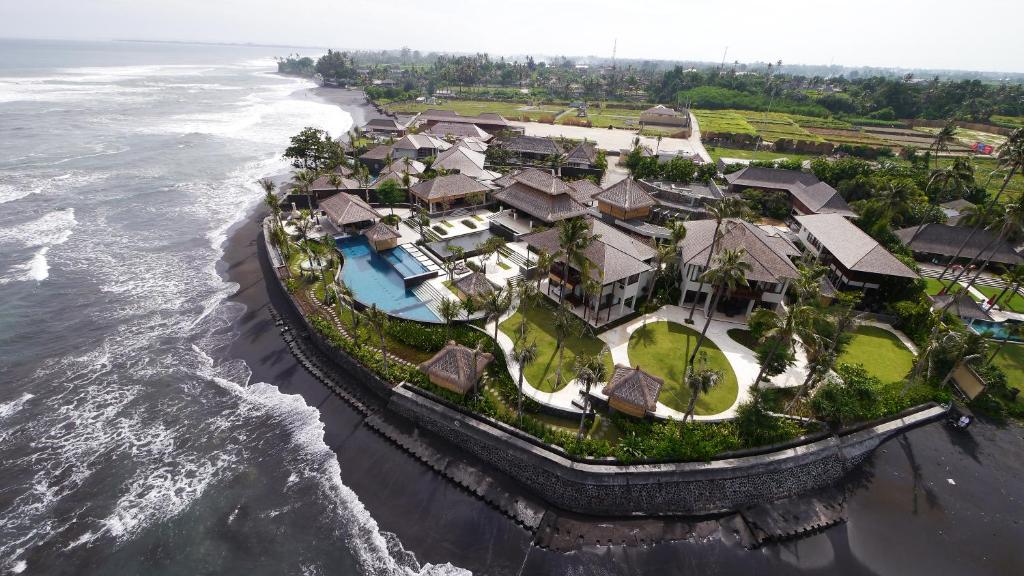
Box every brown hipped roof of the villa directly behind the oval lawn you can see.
[680,218,800,282]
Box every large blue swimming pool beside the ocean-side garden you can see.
[336,236,440,322]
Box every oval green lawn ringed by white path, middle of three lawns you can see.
[629,322,739,415]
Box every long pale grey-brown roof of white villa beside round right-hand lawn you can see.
[797,214,918,278]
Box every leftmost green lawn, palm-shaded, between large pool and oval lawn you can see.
[499,302,611,392]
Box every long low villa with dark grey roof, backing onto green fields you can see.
[725,166,857,218]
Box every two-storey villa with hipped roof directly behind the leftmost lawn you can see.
[522,217,656,326]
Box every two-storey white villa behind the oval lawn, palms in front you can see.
[679,218,800,317]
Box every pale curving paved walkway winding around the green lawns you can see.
[486,305,807,421]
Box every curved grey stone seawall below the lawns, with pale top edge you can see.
[388,386,944,516]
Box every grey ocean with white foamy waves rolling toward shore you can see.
[0,40,461,574]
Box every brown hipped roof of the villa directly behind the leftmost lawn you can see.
[522,217,656,284]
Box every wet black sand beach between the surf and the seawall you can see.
[220,89,1024,575]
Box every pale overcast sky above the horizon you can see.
[6,0,1024,72]
